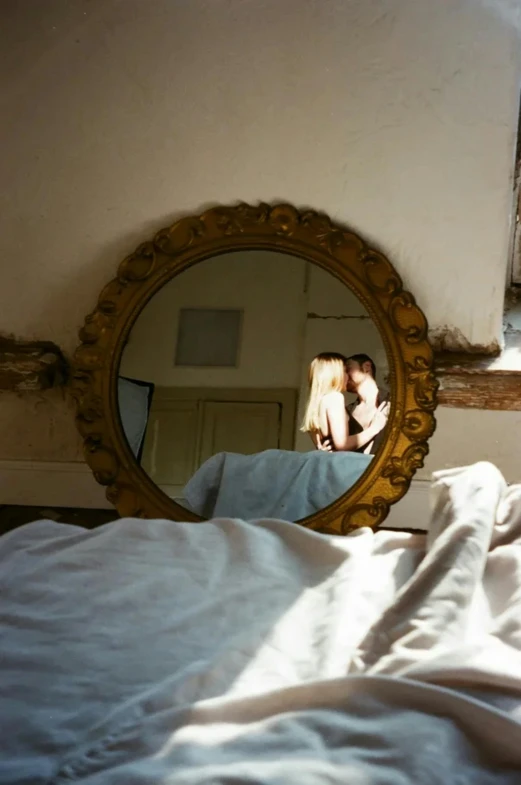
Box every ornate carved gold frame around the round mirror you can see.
[71,203,438,535]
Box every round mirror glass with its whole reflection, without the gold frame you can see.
[118,250,390,521]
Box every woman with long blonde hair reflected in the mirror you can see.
[301,352,387,452]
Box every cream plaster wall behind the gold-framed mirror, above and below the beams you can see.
[0,0,521,508]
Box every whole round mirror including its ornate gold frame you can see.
[73,205,437,534]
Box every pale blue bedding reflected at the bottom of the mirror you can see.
[183,450,373,521]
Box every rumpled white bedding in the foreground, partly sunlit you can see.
[0,463,521,785]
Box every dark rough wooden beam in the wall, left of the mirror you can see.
[0,338,67,392]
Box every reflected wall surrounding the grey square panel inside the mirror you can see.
[121,251,306,389]
